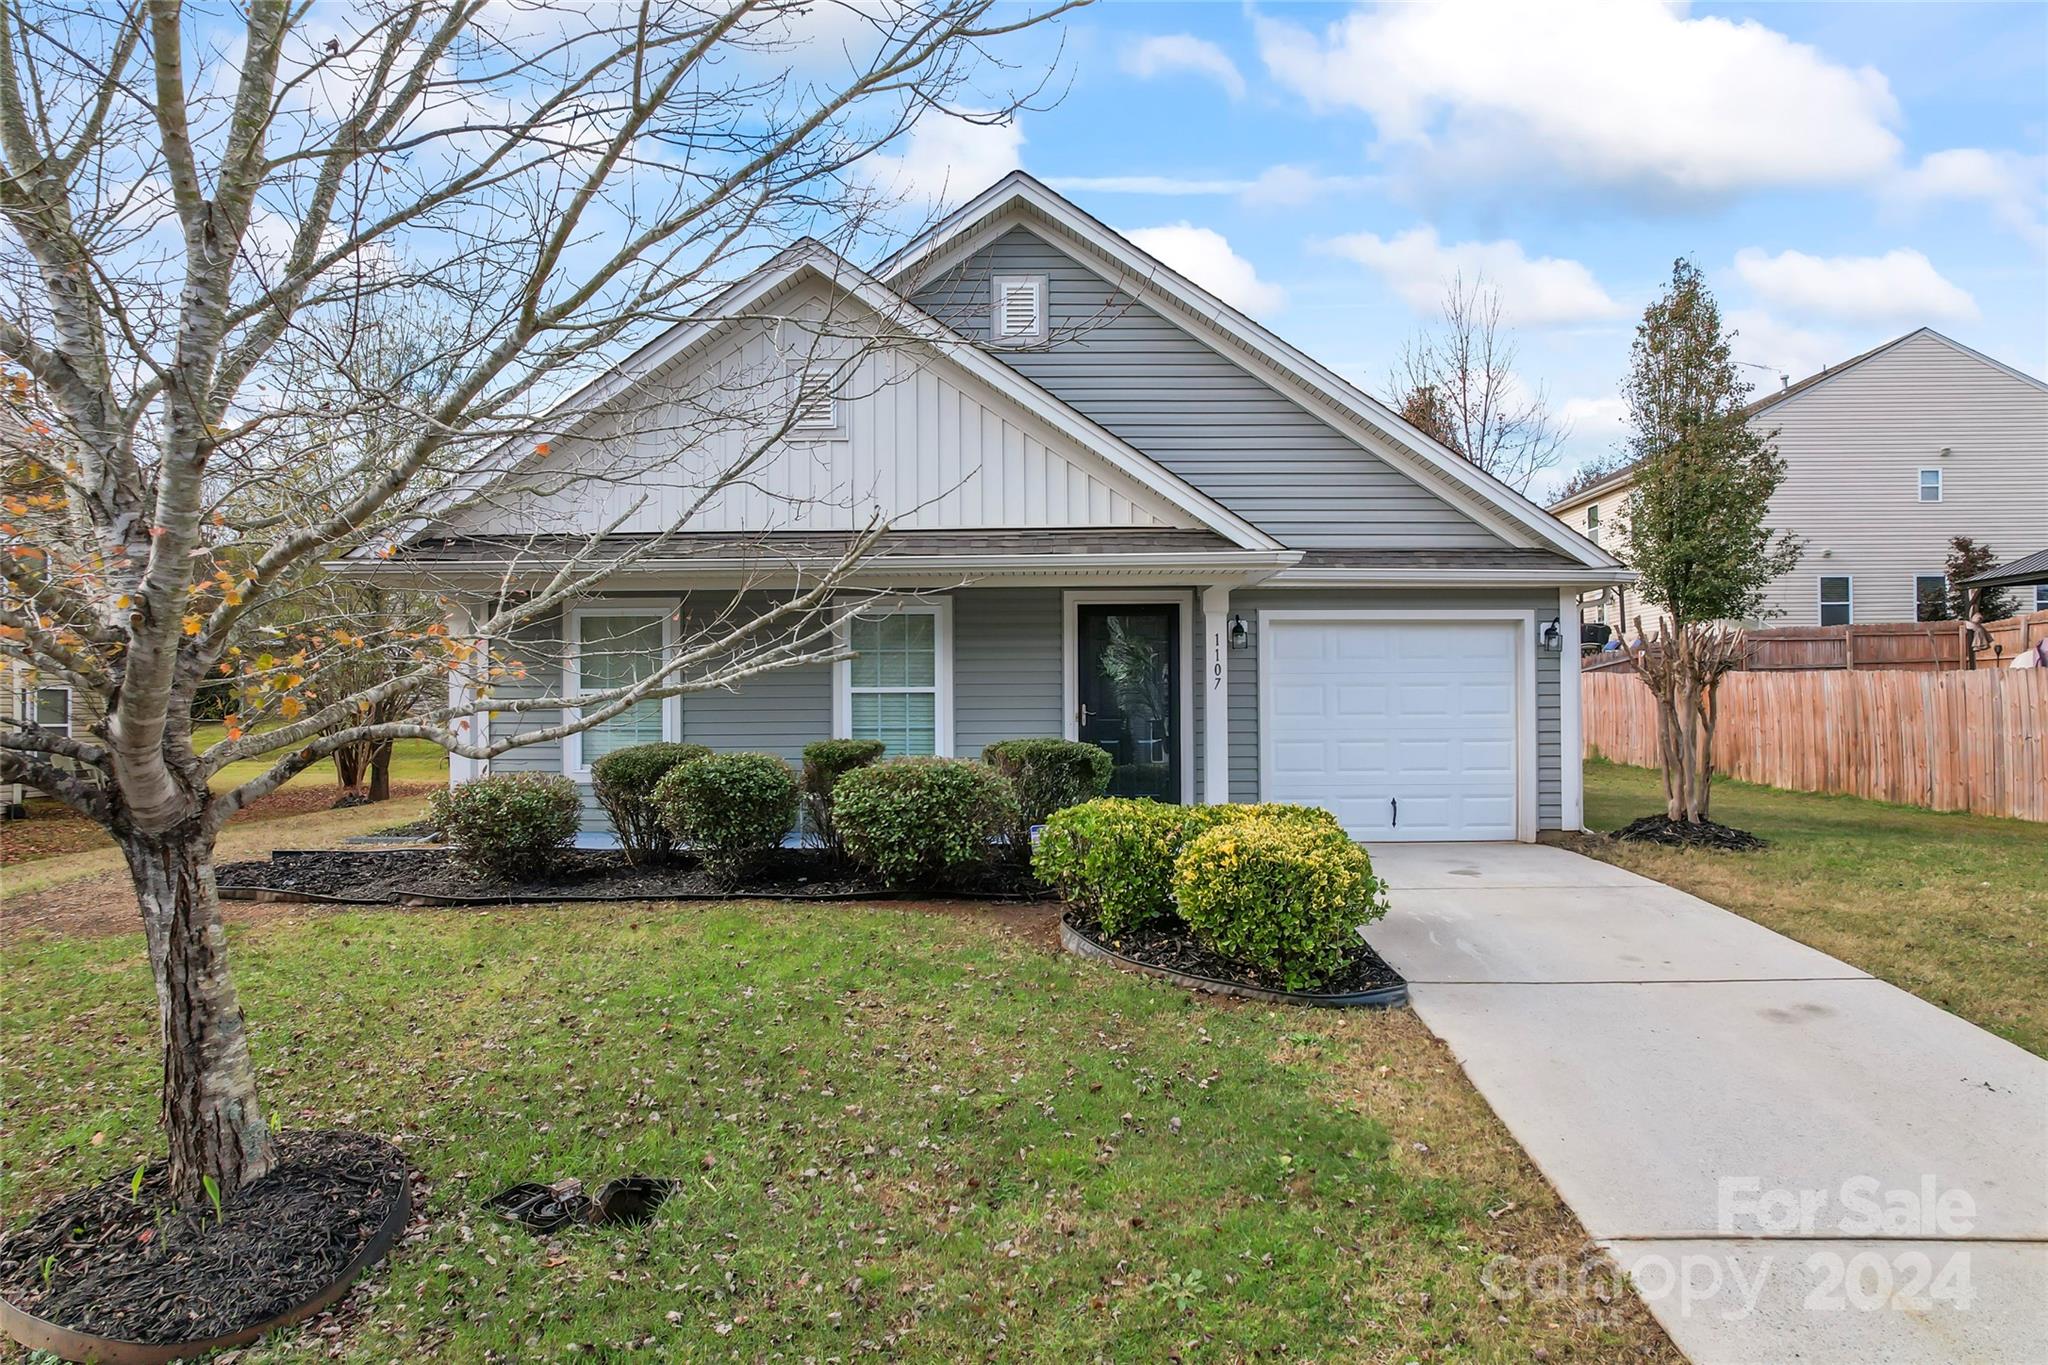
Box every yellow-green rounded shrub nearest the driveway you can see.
[1174,808,1386,990]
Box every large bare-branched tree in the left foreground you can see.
[0,0,1071,1201]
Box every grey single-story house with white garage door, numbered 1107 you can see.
[352,174,1626,839]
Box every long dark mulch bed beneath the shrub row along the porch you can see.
[215,849,1044,905]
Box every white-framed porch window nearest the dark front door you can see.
[836,602,952,757]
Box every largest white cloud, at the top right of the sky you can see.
[1255,0,1901,194]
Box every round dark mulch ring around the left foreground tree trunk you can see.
[0,1132,410,1345]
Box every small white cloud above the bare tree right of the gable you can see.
[1329,227,1622,327]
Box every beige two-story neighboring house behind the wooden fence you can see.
[1550,327,2048,632]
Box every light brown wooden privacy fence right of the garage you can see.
[1579,669,2048,821]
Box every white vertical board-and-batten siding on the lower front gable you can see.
[446,282,1196,534]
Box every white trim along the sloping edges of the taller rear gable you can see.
[874,170,1620,569]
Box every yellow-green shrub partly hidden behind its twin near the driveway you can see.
[1032,796,1341,935]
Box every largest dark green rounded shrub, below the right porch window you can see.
[831,759,1018,886]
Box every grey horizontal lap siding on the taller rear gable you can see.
[913,227,1503,548]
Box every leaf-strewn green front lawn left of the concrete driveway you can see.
[0,905,1677,1363]
